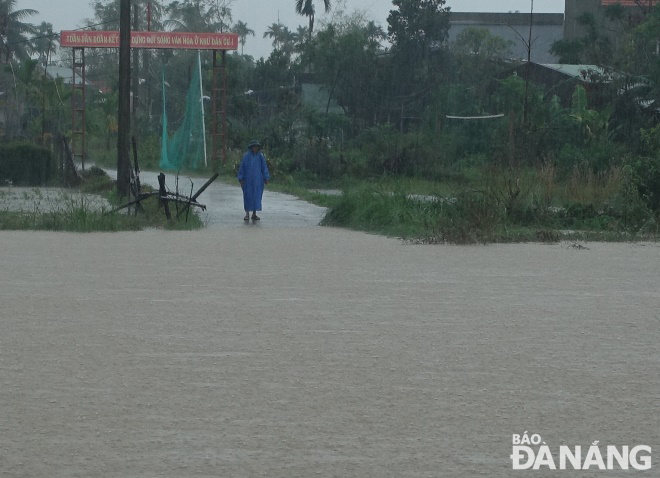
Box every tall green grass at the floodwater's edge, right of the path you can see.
[321,170,659,244]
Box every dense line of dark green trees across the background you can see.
[0,0,660,224]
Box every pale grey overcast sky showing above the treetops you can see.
[16,0,564,58]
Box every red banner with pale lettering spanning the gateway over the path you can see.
[60,30,238,50]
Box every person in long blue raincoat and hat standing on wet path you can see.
[237,140,270,221]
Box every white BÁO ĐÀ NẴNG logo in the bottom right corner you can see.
[511,432,651,470]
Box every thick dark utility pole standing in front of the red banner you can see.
[117,0,131,196]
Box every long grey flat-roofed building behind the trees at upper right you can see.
[449,12,564,63]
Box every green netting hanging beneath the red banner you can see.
[160,57,205,171]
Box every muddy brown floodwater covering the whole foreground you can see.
[0,230,660,478]
